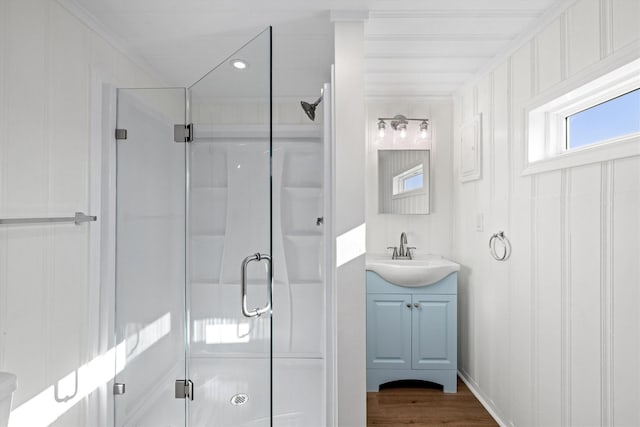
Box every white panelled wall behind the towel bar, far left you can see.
[0,0,162,426]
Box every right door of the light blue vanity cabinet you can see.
[411,295,458,369]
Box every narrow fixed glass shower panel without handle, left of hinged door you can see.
[114,89,188,427]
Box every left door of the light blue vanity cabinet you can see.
[367,294,412,369]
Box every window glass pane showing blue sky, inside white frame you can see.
[566,89,640,150]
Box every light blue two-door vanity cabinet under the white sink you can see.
[367,271,458,393]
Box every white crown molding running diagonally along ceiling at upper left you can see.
[56,0,165,83]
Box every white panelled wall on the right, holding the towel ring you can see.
[453,0,640,426]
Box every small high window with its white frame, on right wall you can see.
[522,55,640,175]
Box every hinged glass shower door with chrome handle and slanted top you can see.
[188,29,272,427]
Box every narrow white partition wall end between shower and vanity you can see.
[329,18,366,427]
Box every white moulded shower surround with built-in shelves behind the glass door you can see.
[189,99,326,427]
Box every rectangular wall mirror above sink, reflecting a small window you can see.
[378,150,430,214]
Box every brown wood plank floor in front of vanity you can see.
[367,378,498,427]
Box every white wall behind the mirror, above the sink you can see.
[366,99,453,257]
